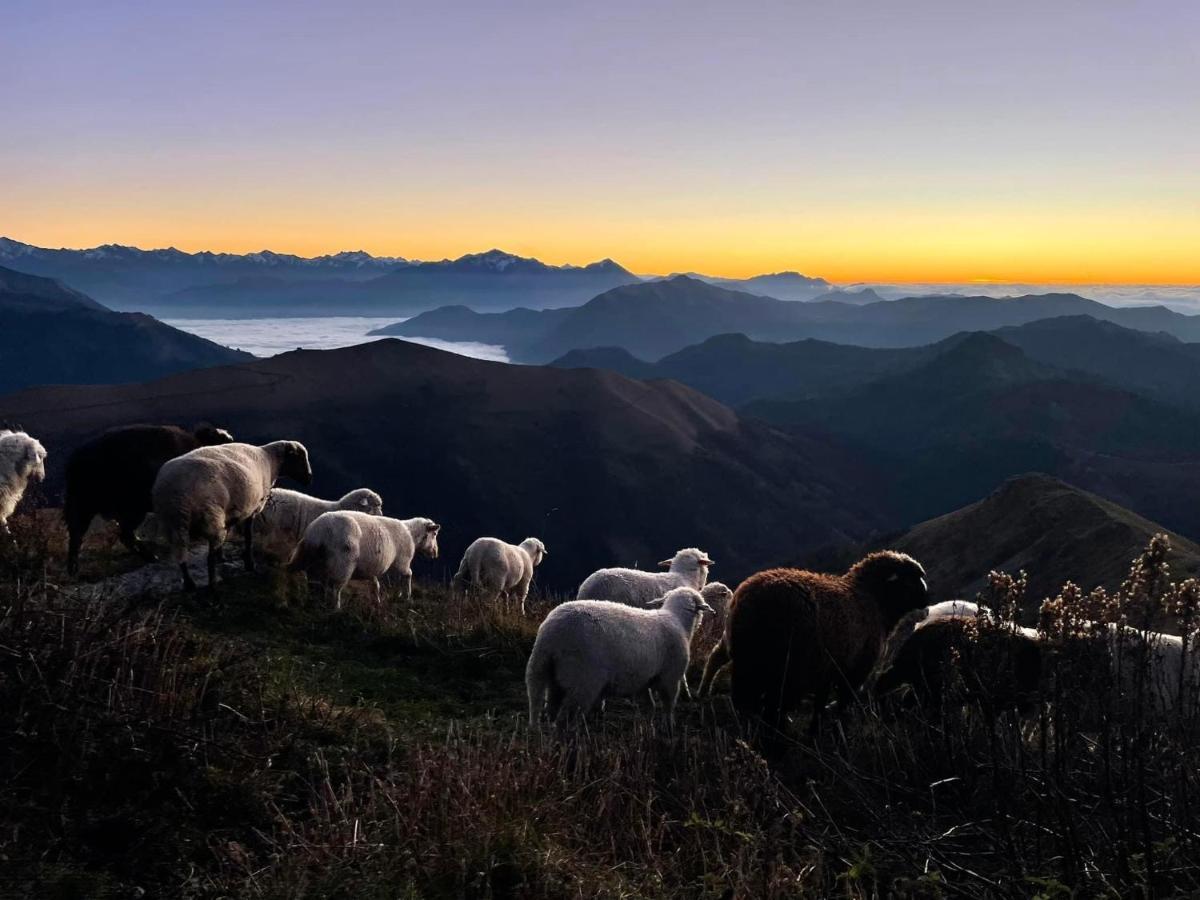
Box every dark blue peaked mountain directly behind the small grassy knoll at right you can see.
[744,334,1200,534]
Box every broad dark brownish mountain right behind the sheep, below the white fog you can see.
[0,340,886,589]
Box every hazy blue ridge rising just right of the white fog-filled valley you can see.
[374,275,1200,362]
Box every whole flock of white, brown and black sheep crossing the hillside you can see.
[0,424,1200,733]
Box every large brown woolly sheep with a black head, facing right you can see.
[700,551,929,733]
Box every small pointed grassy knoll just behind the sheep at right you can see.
[888,474,1200,610]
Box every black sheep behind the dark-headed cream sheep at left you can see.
[62,425,233,575]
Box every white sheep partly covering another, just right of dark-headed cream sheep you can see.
[288,510,442,610]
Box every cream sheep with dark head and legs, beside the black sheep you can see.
[151,440,312,590]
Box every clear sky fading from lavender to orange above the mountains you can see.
[0,0,1200,284]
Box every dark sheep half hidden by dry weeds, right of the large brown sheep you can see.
[875,616,1042,713]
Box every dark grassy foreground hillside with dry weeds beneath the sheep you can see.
[7,517,1200,898]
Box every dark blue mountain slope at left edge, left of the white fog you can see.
[0,266,253,392]
